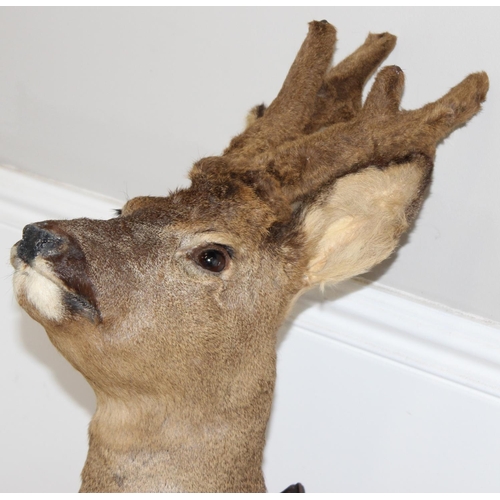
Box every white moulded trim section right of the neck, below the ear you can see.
[293,280,500,397]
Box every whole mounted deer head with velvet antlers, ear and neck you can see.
[12,21,488,492]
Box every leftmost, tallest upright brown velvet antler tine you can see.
[224,21,336,158]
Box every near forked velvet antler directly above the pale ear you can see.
[250,66,488,202]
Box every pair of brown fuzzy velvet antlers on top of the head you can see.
[191,21,488,225]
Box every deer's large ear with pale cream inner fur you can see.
[303,157,432,287]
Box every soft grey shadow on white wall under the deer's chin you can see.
[18,306,96,416]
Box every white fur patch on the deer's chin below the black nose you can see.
[14,265,64,321]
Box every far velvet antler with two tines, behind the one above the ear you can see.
[224,21,396,159]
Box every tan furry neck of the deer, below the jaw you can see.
[80,362,275,492]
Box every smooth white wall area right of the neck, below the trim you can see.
[264,320,500,493]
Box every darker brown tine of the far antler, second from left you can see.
[305,33,397,134]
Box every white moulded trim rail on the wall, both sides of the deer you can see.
[0,166,500,397]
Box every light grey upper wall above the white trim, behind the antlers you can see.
[0,7,500,321]
